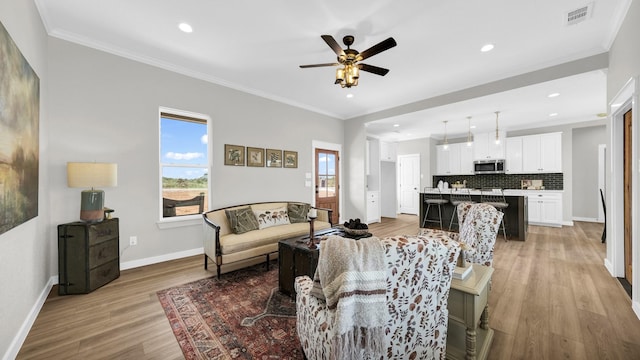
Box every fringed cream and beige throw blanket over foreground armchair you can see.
[311,236,387,359]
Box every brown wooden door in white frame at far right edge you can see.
[623,110,633,284]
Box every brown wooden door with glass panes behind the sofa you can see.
[316,149,340,224]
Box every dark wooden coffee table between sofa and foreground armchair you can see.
[278,227,371,299]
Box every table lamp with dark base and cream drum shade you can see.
[67,162,118,222]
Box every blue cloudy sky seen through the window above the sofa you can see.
[160,117,208,179]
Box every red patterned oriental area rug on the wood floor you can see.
[158,264,303,360]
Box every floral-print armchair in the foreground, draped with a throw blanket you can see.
[295,236,460,360]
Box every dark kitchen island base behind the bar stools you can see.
[420,189,529,241]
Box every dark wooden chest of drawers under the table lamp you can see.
[58,218,120,295]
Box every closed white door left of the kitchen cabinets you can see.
[398,154,420,215]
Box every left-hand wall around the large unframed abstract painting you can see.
[0,0,50,359]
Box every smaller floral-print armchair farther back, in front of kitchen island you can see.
[418,203,504,266]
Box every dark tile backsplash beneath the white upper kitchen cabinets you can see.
[433,173,564,190]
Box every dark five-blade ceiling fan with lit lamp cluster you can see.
[300,35,397,88]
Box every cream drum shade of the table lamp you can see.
[67,162,118,188]
